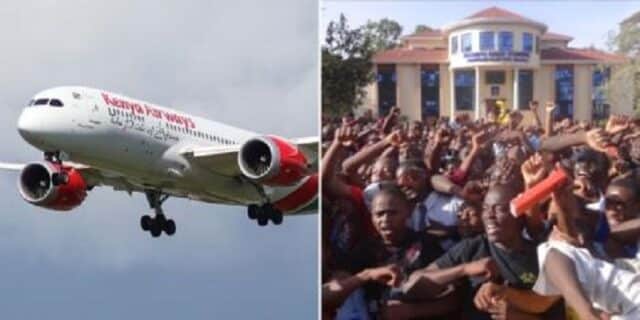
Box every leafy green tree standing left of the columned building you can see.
[322,14,402,115]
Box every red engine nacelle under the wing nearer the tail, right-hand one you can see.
[238,136,309,186]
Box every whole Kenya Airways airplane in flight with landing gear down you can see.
[0,86,318,238]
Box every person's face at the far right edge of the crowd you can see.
[605,185,638,226]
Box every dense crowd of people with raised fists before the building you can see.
[321,101,640,320]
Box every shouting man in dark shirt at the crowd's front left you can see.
[332,183,453,318]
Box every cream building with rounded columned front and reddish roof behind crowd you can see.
[362,7,632,120]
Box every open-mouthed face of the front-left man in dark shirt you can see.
[371,193,411,245]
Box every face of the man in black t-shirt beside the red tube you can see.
[482,188,520,246]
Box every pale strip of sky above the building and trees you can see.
[320,1,640,49]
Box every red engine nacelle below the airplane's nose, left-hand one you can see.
[18,162,87,211]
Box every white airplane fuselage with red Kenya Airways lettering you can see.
[18,87,287,204]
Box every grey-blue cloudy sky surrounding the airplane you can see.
[0,0,319,319]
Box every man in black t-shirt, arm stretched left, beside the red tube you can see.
[403,185,554,319]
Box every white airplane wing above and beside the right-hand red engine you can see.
[181,137,318,176]
